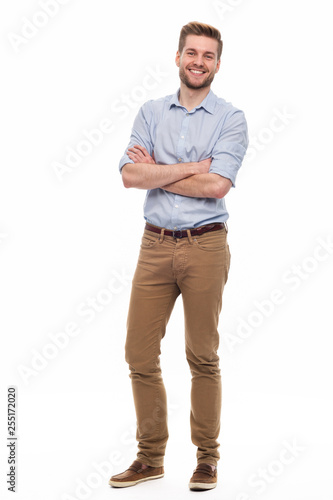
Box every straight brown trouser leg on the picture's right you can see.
[178,230,230,465]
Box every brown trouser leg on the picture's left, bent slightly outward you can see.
[125,231,180,467]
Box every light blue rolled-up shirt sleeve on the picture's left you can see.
[119,101,153,172]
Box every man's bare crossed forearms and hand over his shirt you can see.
[122,145,232,198]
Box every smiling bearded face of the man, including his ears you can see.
[176,35,221,90]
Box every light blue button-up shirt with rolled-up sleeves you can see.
[119,90,248,230]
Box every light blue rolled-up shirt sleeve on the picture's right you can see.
[209,110,249,187]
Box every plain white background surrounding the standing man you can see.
[0,0,333,500]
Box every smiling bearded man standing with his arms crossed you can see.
[109,22,248,490]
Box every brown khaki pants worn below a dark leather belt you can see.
[125,228,230,467]
